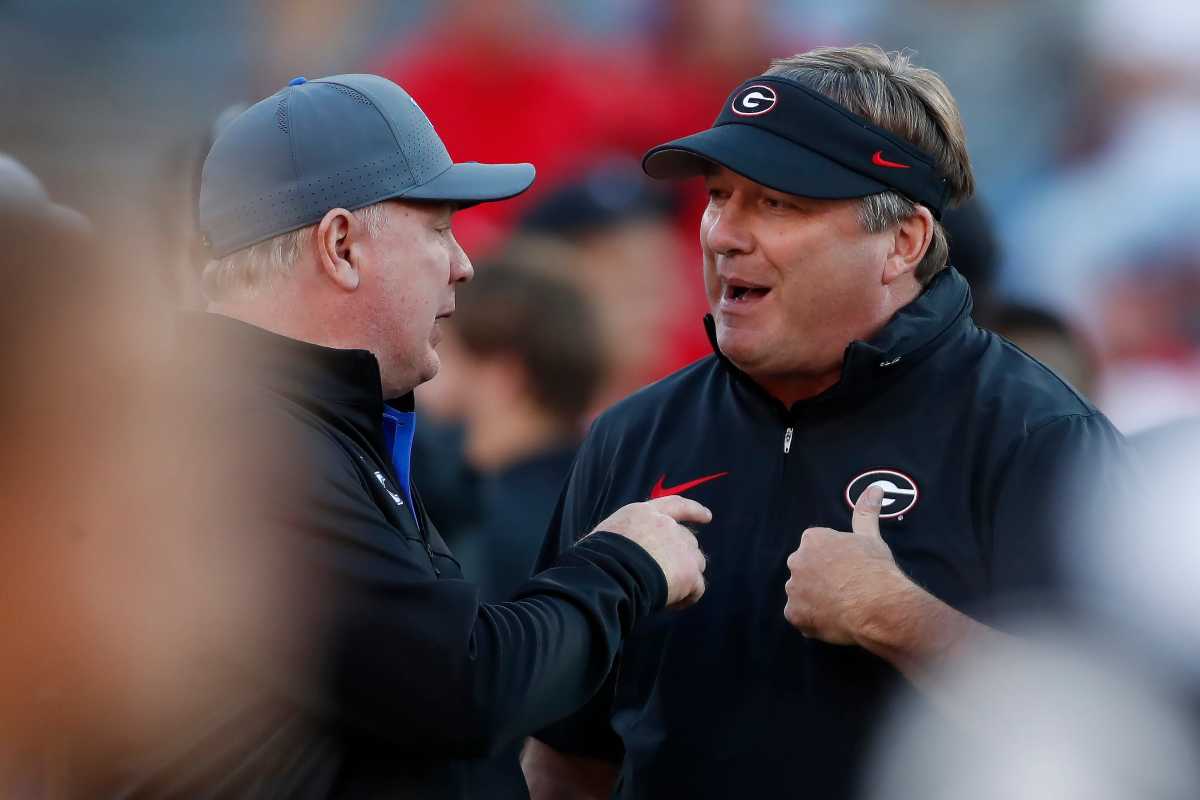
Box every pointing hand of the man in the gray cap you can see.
[593,495,713,608]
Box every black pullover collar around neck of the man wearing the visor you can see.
[704,267,971,411]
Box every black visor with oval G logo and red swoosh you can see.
[642,76,949,219]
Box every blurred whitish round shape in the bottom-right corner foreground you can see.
[860,626,1200,800]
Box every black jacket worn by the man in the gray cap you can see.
[121,314,666,798]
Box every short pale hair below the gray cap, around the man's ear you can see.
[203,203,388,301]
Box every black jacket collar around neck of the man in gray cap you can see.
[181,313,413,452]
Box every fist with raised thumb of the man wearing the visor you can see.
[784,486,913,644]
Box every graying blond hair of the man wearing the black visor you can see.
[767,44,974,285]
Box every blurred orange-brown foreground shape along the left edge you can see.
[0,156,297,796]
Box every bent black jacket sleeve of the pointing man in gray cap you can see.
[274,424,667,758]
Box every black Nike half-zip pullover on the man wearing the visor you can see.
[539,270,1127,800]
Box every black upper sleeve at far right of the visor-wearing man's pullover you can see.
[989,413,1140,615]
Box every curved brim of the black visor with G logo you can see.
[642,124,888,199]
